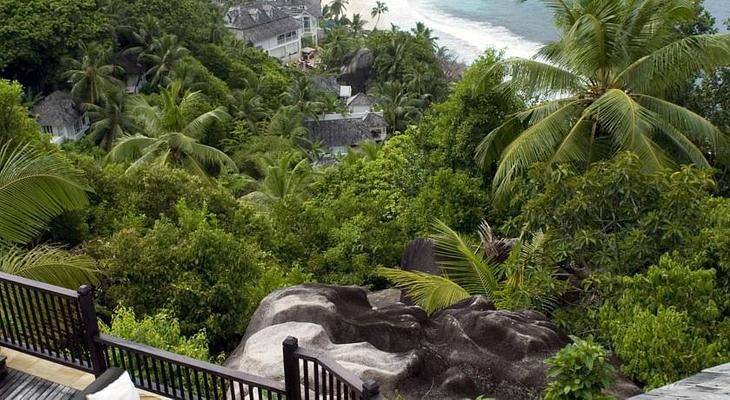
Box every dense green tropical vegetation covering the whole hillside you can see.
[0,0,730,399]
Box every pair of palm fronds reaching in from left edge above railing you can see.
[0,143,96,288]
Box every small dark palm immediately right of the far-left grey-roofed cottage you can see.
[84,87,134,151]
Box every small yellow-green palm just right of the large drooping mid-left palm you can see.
[243,152,314,205]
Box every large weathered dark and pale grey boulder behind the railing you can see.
[226,285,568,399]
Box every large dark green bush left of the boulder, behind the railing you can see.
[90,202,307,352]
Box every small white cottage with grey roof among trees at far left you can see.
[31,91,89,143]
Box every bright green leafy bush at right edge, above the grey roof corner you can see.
[597,254,730,388]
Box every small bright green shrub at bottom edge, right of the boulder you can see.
[545,336,614,400]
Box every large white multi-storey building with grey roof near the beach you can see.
[225,1,304,62]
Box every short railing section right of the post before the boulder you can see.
[283,336,382,400]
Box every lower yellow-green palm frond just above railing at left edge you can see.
[0,246,98,289]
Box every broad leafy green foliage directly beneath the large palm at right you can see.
[511,153,714,274]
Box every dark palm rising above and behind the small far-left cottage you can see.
[64,43,123,104]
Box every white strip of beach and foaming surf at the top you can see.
[348,0,541,63]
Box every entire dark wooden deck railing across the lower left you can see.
[0,273,381,400]
